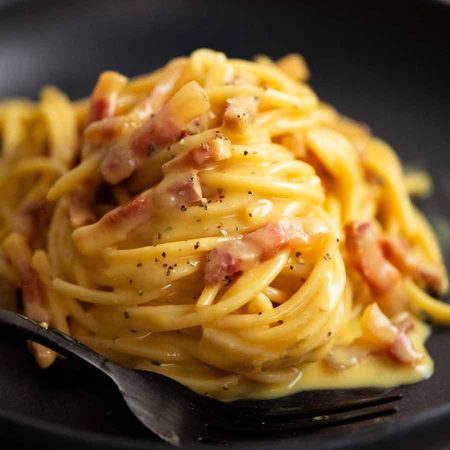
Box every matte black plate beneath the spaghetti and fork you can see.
[0,0,450,450]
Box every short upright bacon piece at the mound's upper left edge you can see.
[87,71,128,125]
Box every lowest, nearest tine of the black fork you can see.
[207,405,398,437]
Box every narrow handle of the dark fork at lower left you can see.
[0,309,113,376]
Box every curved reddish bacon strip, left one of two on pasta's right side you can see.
[345,222,400,296]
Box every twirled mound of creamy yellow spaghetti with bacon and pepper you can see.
[0,49,450,400]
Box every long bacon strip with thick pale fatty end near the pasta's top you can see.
[100,81,209,184]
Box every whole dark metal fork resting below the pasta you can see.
[0,309,401,446]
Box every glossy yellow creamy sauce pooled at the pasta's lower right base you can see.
[250,321,434,399]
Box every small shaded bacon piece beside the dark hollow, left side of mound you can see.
[69,180,97,228]
